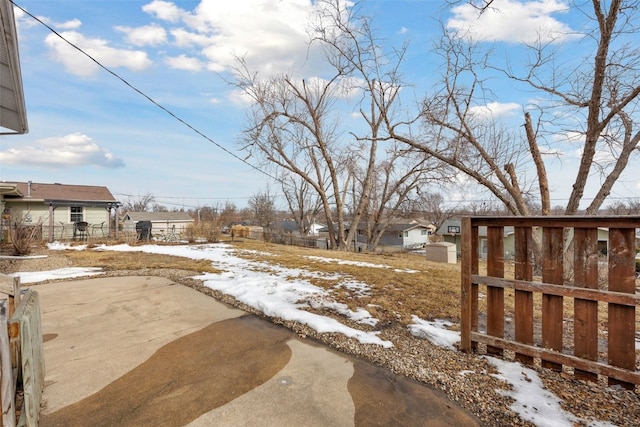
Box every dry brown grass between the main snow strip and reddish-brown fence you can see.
[225,240,460,324]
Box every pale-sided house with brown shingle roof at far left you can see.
[0,181,120,241]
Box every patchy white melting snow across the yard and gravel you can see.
[13,242,624,427]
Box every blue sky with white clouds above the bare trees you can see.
[0,0,640,209]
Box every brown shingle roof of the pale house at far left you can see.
[5,182,116,203]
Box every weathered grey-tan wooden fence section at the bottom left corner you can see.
[0,274,45,426]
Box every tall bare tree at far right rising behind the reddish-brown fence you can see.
[507,0,640,215]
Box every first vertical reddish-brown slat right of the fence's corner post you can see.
[487,226,504,355]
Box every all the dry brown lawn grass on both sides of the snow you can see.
[55,239,460,324]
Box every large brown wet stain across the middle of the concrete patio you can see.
[40,316,292,427]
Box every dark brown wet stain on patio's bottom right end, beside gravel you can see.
[348,361,480,427]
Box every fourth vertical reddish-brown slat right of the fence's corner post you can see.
[573,228,598,381]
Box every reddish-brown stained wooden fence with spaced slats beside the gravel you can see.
[461,217,640,389]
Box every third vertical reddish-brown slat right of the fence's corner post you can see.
[542,227,564,371]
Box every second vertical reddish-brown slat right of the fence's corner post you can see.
[514,227,533,365]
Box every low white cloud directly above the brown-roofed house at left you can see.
[0,132,124,169]
